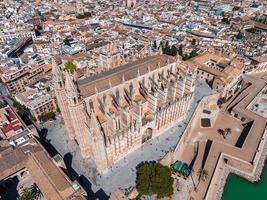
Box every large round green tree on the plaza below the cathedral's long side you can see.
[136,162,173,198]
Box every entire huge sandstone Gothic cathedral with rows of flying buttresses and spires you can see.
[53,55,195,173]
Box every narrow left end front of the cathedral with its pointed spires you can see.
[52,60,109,172]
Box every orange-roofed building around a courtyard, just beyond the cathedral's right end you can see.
[183,52,244,97]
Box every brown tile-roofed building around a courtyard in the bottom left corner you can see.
[0,137,86,200]
